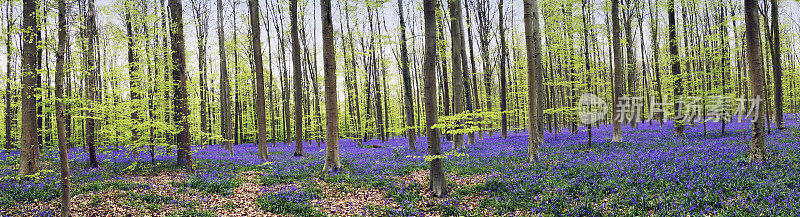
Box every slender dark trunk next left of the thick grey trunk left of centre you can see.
[290,0,303,156]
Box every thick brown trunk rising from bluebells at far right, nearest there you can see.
[744,0,767,164]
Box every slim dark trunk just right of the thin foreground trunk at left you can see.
[83,0,99,167]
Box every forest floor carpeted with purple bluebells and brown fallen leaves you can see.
[0,115,800,216]
